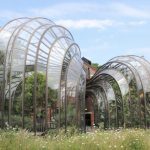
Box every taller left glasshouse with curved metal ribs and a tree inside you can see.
[0,18,86,133]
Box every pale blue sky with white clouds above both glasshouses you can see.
[0,0,150,64]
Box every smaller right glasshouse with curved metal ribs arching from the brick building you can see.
[86,55,150,128]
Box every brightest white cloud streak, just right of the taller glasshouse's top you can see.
[56,19,114,29]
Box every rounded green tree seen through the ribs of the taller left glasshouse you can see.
[13,73,58,114]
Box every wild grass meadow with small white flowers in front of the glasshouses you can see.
[0,129,150,150]
